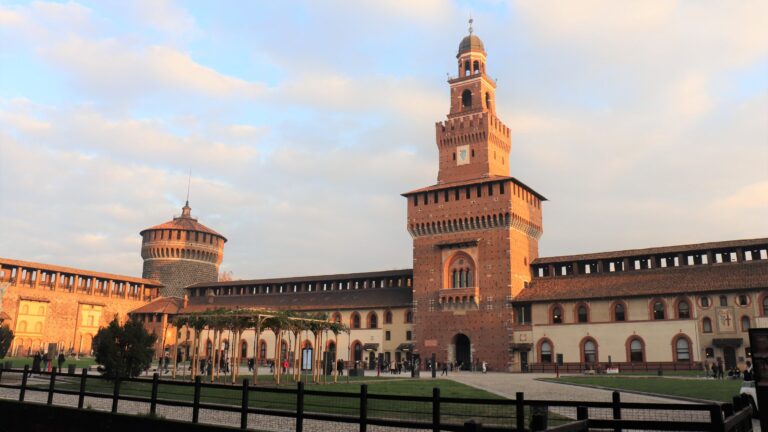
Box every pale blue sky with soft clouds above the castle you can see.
[0,0,768,279]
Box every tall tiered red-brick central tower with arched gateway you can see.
[403,27,546,371]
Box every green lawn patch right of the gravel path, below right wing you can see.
[545,376,742,402]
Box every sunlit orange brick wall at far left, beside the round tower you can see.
[0,258,159,355]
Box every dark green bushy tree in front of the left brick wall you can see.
[93,317,157,379]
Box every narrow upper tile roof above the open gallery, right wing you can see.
[531,238,768,265]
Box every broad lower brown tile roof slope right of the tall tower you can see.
[514,260,768,302]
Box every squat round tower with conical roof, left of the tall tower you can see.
[140,201,227,297]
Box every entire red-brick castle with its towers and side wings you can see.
[0,32,768,371]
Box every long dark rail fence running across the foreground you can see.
[0,367,752,432]
